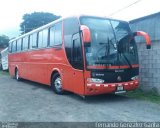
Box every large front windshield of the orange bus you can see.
[80,17,138,68]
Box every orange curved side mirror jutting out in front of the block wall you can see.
[134,31,151,49]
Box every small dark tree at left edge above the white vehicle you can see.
[0,35,9,48]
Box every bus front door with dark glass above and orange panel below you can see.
[71,33,84,95]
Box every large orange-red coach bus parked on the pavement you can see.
[9,15,151,96]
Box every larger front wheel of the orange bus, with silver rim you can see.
[51,73,64,95]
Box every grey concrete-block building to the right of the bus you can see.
[130,12,160,94]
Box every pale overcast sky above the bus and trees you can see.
[0,0,160,38]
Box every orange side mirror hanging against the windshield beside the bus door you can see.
[80,25,91,43]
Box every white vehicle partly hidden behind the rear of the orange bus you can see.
[1,47,8,70]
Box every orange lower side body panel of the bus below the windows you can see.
[9,45,84,95]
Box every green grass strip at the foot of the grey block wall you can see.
[125,89,160,104]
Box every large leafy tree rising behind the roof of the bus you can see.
[20,12,60,34]
